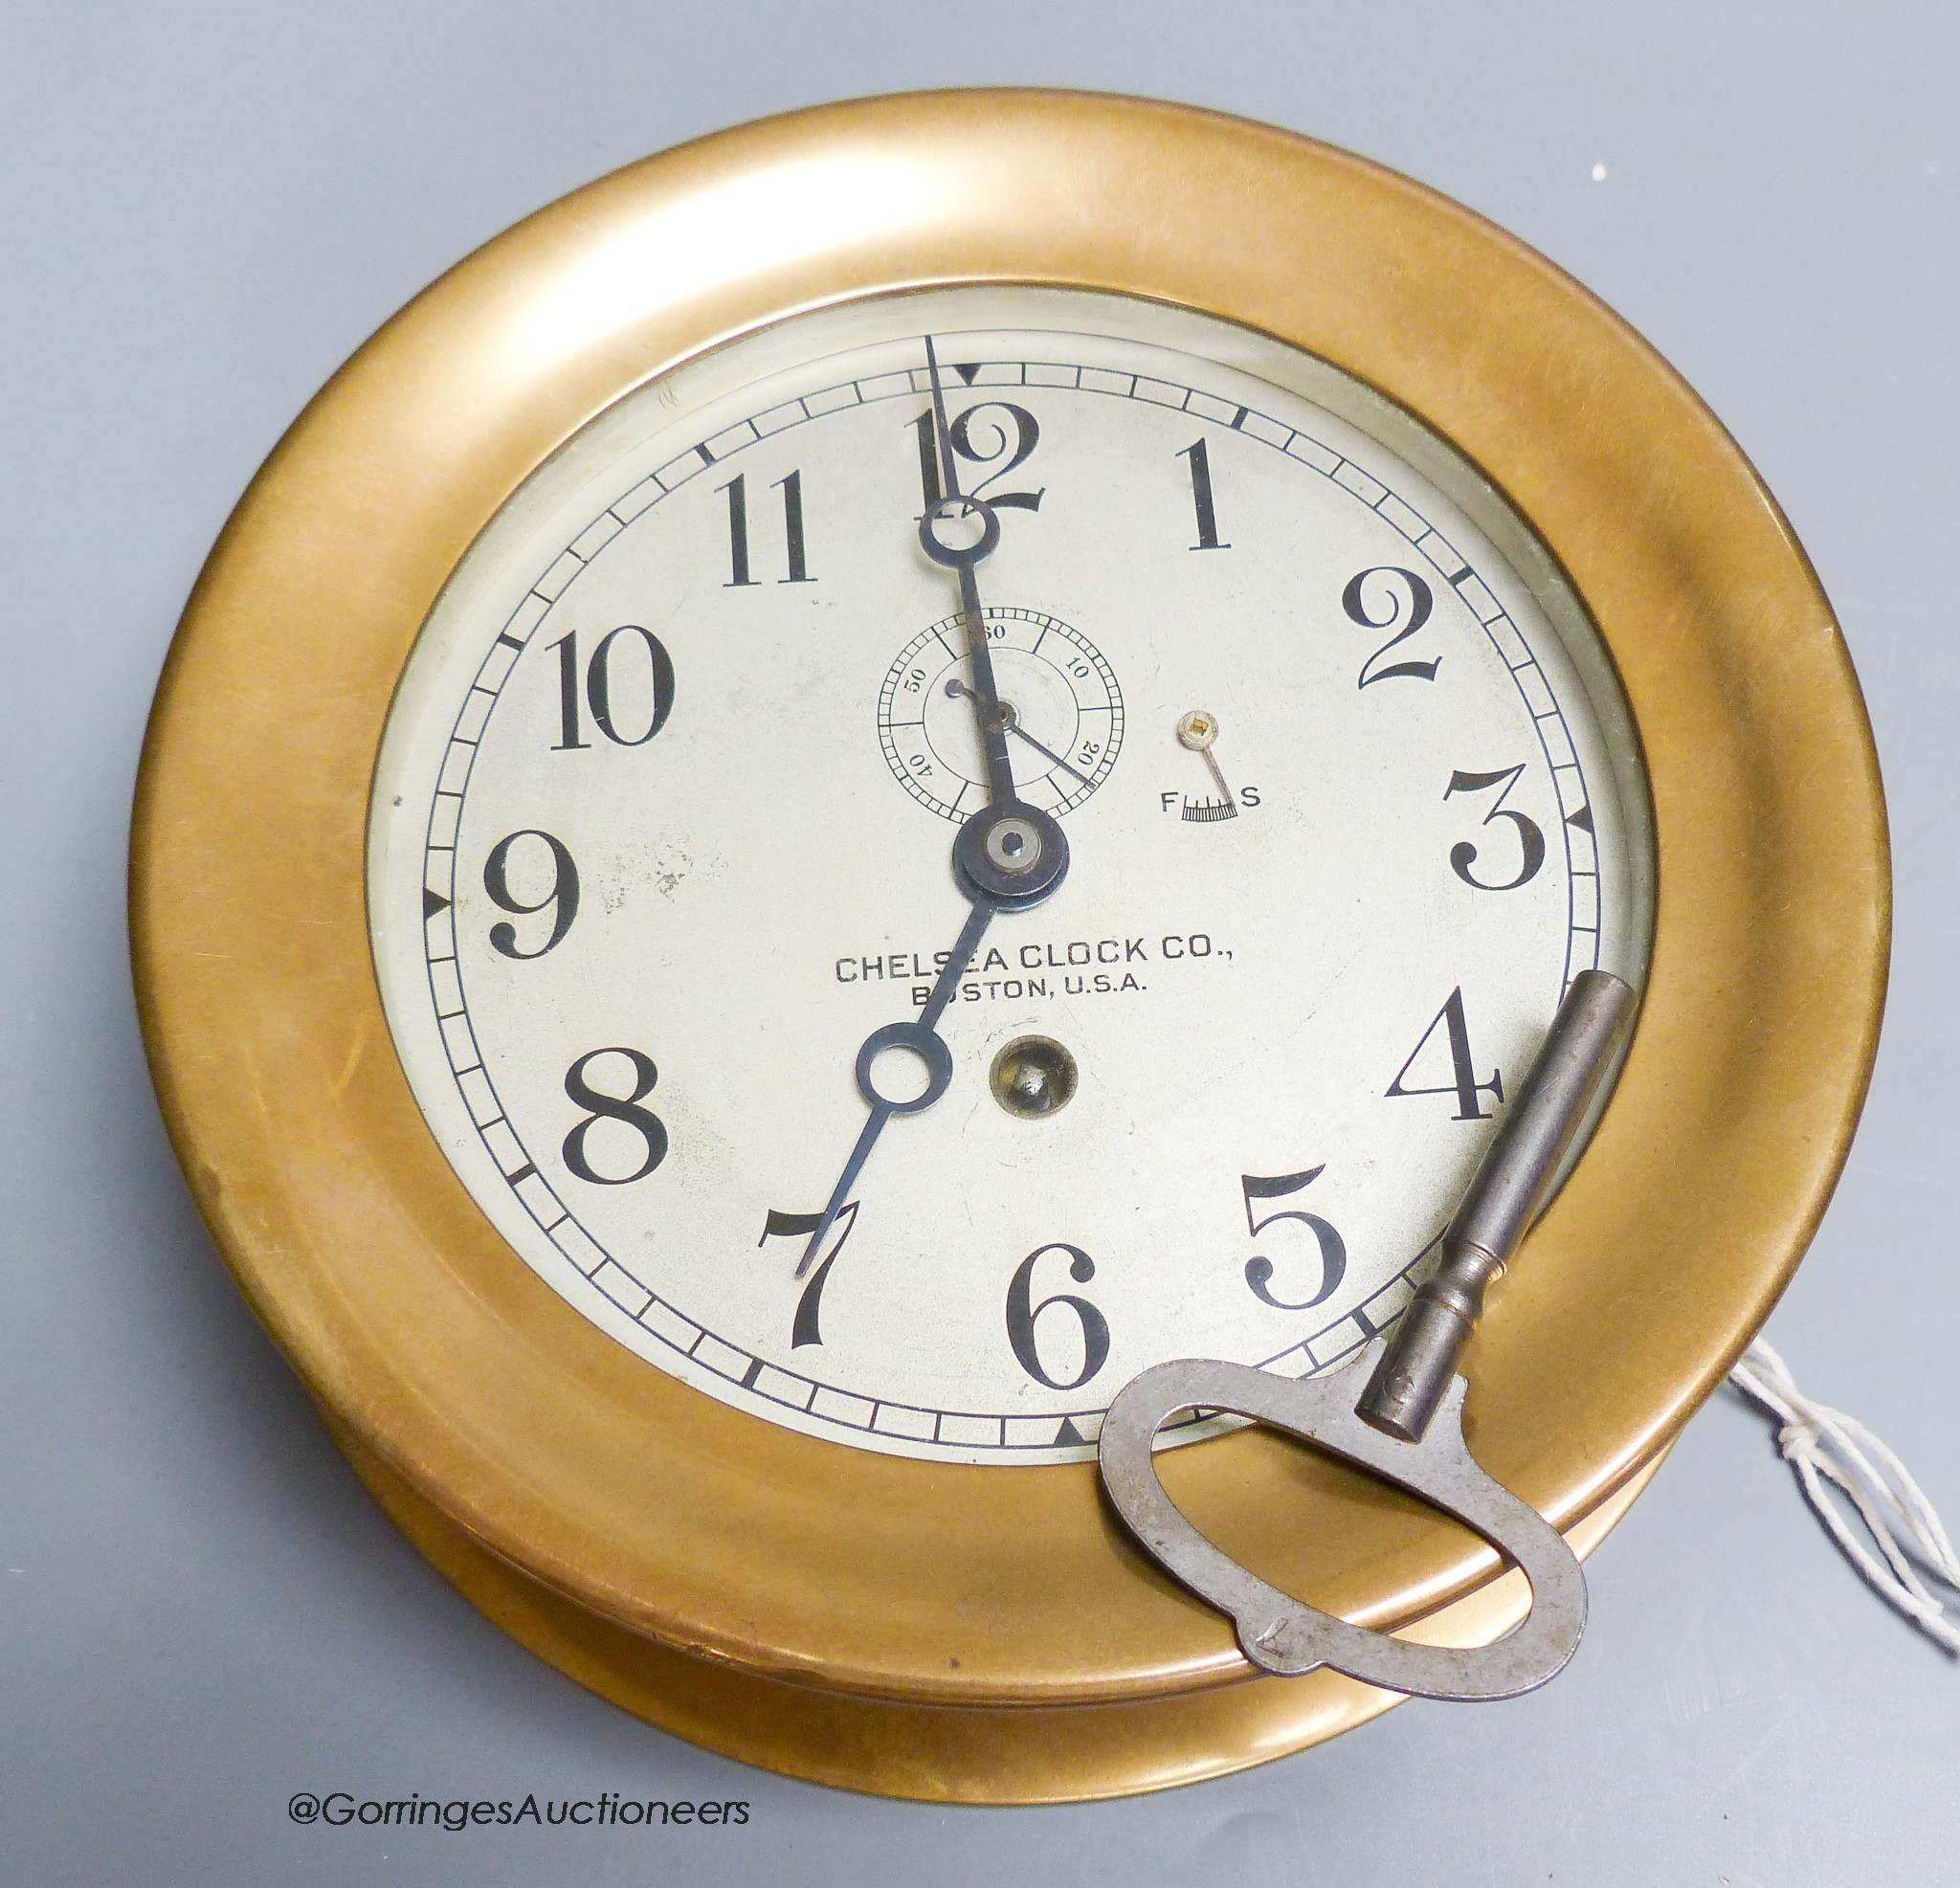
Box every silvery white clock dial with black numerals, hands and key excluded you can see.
[368,288,1652,1462]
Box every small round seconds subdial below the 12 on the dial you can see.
[879,606,1124,819]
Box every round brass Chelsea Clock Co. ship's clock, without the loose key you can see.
[135,92,1887,1802]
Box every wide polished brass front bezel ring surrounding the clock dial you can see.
[133,92,1887,1772]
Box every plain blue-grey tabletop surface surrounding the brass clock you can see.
[0,0,1960,1888]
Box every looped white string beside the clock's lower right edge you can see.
[1728,1337,1960,1656]
